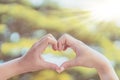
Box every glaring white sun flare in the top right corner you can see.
[91,0,120,21]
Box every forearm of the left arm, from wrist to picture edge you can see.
[0,58,26,80]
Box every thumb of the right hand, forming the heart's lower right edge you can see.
[57,59,76,73]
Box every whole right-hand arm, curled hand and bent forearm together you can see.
[57,34,119,80]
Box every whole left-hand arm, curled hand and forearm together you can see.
[0,34,58,80]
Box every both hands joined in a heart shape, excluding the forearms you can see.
[19,34,107,73]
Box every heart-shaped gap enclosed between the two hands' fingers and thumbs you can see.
[42,47,75,73]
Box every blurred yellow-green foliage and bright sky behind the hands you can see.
[0,0,120,80]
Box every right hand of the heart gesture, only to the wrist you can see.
[58,34,106,69]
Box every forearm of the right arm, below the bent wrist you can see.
[88,47,119,80]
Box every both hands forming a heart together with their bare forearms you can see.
[0,34,119,80]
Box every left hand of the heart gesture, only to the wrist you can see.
[20,34,58,72]
